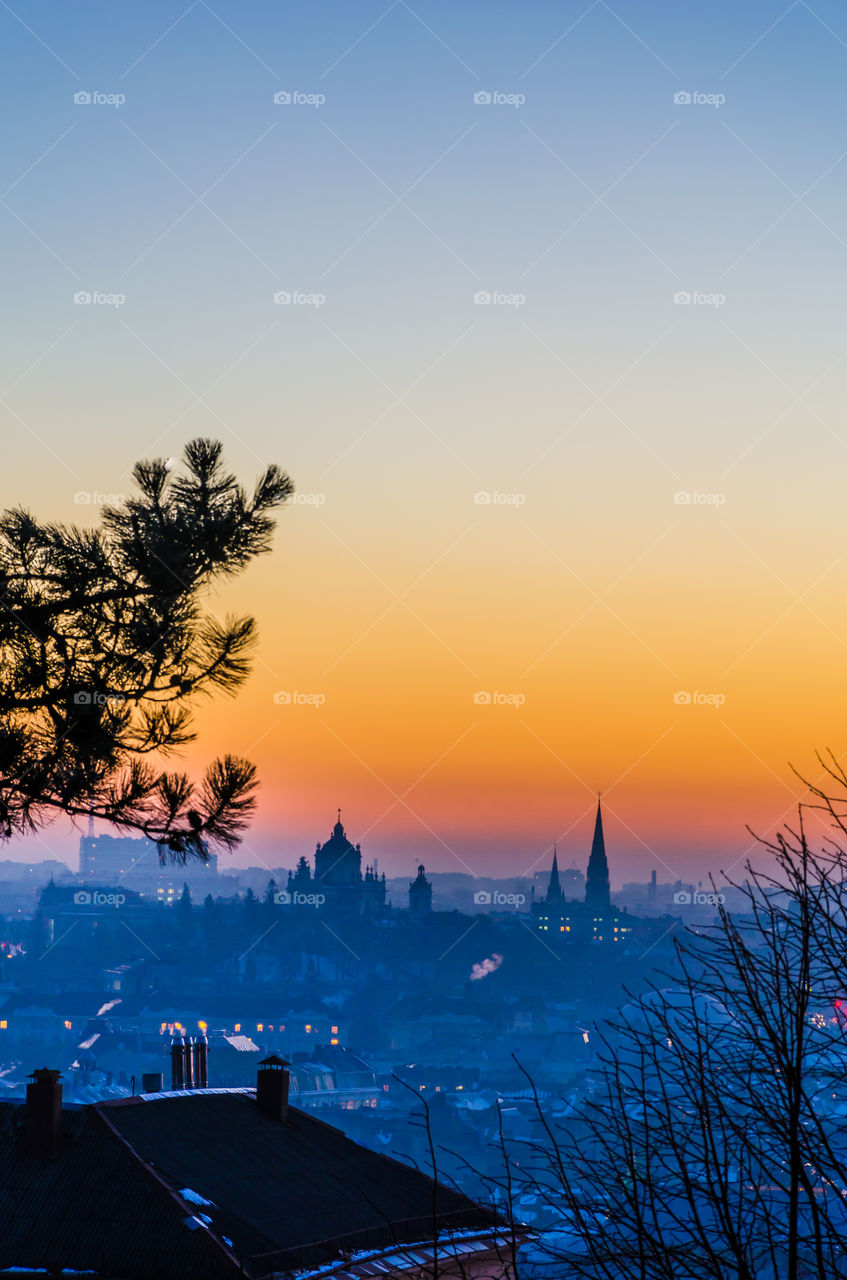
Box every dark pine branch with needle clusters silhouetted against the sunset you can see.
[0,439,293,860]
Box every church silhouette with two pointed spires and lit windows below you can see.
[532,800,632,942]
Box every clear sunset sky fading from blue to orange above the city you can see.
[0,0,847,884]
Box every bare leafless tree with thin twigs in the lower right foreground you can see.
[491,809,847,1280]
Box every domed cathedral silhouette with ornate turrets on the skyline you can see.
[288,809,385,915]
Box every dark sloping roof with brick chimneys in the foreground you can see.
[0,1091,491,1280]
